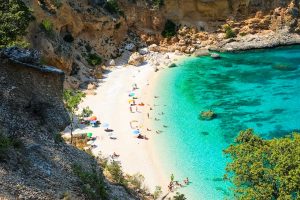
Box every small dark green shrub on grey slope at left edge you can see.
[0,133,22,161]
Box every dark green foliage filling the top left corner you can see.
[0,0,33,48]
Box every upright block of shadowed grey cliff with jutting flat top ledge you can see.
[0,48,69,134]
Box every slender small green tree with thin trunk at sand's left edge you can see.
[64,90,85,144]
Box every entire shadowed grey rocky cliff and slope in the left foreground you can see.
[0,48,134,200]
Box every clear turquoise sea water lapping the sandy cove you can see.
[154,46,300,200]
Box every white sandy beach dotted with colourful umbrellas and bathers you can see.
[65,53,184,192]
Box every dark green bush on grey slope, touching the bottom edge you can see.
[72,165,108,200]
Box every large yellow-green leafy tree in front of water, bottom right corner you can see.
[224,129,300,200]
